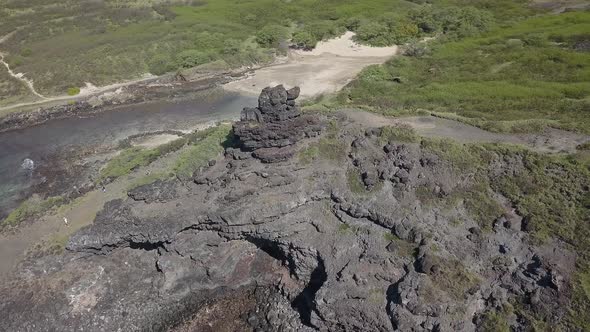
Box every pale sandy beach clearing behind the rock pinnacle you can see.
[224,32,398,97]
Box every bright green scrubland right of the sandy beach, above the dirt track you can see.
[339,11,590,133]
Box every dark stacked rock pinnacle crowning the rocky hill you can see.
[233,85,322,163]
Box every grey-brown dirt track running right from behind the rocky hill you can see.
[341,109,590,153]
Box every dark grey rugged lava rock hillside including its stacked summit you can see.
[0,88,576,331]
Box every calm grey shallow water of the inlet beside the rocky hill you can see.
[0,93,256,217]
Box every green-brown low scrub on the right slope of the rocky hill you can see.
[417,132,590,328]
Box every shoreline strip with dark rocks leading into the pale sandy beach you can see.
[0,32,399,133]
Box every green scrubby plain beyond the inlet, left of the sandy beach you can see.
[0,0,420,100]
